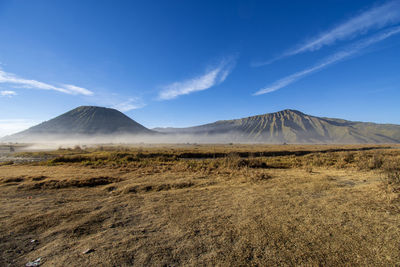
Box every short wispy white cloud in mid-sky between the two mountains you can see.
[158,59,234,100]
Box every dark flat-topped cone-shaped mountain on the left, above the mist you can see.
[5,106,154,139]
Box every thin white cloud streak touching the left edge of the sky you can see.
[0,69,93,96]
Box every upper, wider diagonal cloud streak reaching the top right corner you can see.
[252,0,400,67]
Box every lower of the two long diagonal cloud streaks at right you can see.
[254,26,400,95]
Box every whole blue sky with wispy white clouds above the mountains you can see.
[0,0,400,136]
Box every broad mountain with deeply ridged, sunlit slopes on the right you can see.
[153,109,400,144]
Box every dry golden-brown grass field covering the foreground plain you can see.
[0,145,400,266]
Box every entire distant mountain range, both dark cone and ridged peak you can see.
[2,106,400,144]
